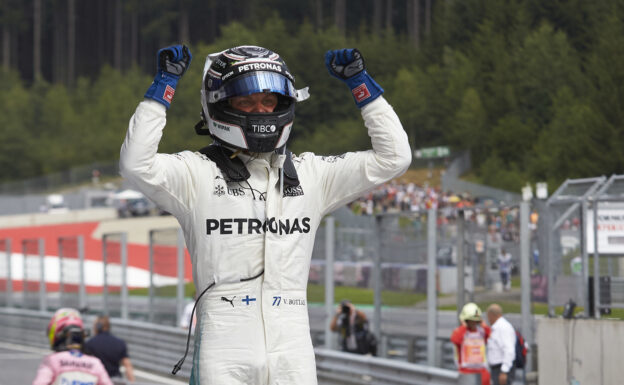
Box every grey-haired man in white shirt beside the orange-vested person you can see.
[487,303,516,385]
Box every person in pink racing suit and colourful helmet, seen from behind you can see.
[32,308,113,385]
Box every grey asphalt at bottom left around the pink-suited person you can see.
[0,342,188,385]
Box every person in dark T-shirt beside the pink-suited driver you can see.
[86,315,134,382]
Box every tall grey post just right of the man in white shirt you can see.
[520,202,533,372]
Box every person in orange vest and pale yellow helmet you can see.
[451,302,491,385]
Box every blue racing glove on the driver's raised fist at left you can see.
[145,45,193,108]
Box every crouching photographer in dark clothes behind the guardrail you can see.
[330,300,377,356]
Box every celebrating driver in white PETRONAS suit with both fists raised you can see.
[120,45,411,385]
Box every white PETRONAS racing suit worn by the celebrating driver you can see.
[120,97,411,385]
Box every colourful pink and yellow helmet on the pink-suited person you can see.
[47,308,85,351]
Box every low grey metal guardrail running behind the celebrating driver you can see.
[0,308,478,385]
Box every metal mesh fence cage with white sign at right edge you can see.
[532,175,624,318]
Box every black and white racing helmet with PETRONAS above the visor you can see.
[196,46,309,152]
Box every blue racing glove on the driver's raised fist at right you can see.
[325,48,383,108]
